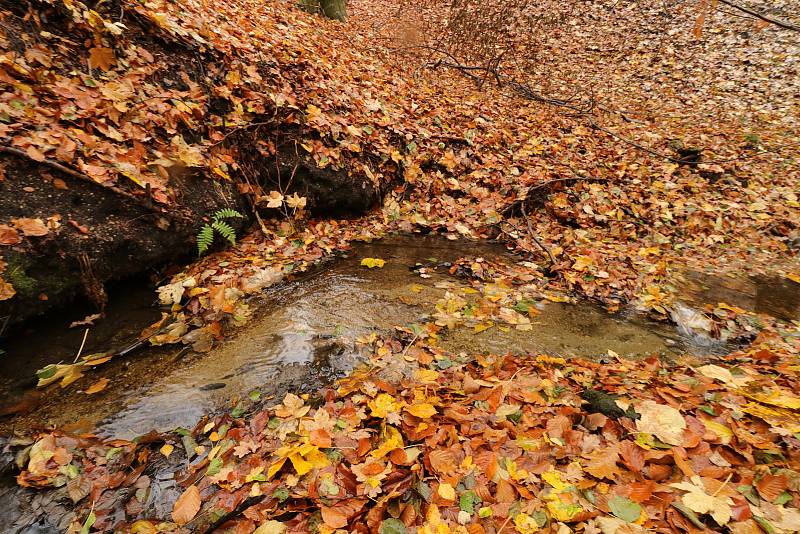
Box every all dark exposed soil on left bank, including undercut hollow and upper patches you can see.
[0,0,382,326]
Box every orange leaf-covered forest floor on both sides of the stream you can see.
[0,0,800,534]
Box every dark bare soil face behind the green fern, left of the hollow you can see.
[0,155,246,324]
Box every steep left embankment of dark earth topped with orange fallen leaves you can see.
[0,0,388,326]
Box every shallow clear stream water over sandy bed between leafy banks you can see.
[0,237,776,438]
